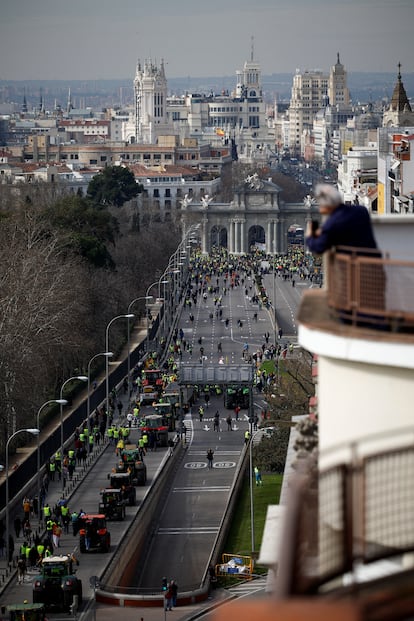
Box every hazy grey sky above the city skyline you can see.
[0,0,414,80]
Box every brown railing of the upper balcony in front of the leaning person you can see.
[327,247,414,331]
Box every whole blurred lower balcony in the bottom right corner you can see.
[277,428,414,621]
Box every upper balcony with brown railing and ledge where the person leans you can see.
[298,248,414,342]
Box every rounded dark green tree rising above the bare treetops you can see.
[87,166,142,207]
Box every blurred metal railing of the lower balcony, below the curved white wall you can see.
[278,430,414,596]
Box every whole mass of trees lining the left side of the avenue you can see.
[0,167,180,459]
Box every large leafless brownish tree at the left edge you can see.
[0,205,89,452]
